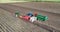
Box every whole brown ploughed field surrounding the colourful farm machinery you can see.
[0,2,60,32]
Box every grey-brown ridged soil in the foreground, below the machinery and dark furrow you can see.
[0,5,48,32]
